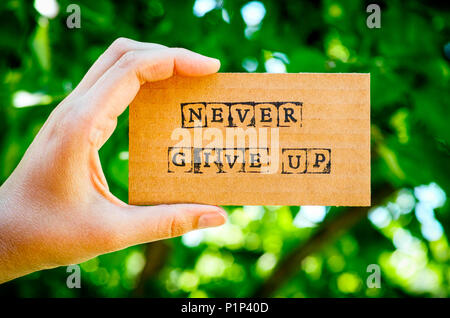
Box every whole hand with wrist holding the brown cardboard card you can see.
[0,39,226,282]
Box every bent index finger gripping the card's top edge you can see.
[86,48,220,118]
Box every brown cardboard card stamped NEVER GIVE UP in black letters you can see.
[129,73,370,206]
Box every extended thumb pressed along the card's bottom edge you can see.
[112,204,227,247]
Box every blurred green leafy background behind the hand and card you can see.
[0,0,450,297]
